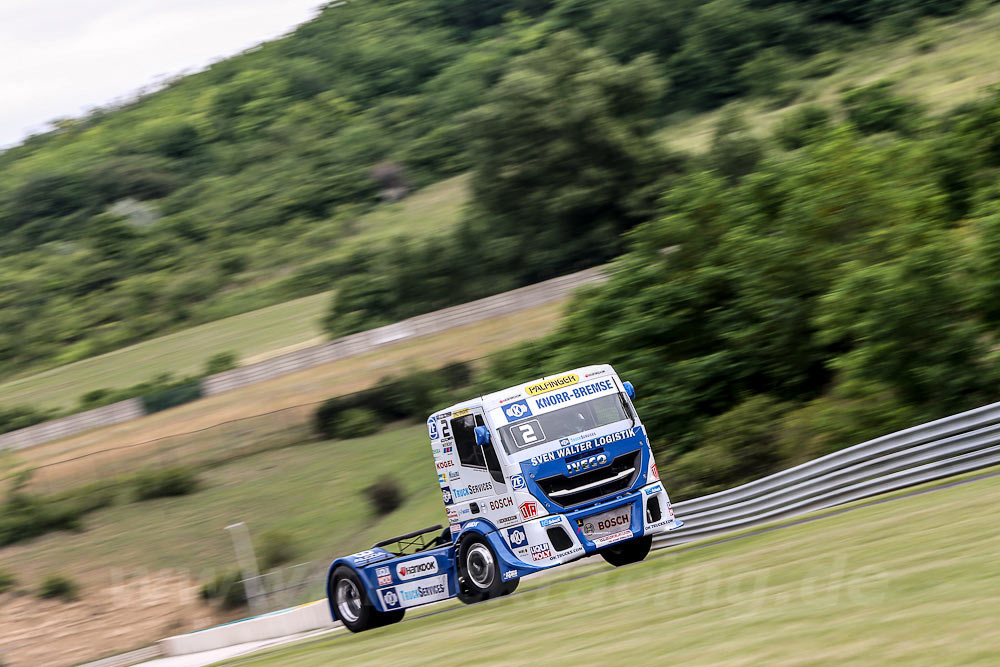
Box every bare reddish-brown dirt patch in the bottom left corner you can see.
[0,571,228,667]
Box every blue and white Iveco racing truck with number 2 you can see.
[327,364,683,632]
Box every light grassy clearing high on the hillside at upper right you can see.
[660,5,1000,151]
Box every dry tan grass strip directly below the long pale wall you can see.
[8,301,565,491]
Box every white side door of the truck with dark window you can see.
[450,408,507,521]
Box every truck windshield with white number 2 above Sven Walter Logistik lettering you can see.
[500,394,632,454]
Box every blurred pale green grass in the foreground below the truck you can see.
[220,470,1000,667]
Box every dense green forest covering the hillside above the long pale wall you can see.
[0,0,965,389]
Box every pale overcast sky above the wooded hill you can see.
[0,0,323,147]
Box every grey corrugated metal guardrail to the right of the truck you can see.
[653,403,1000,548]
